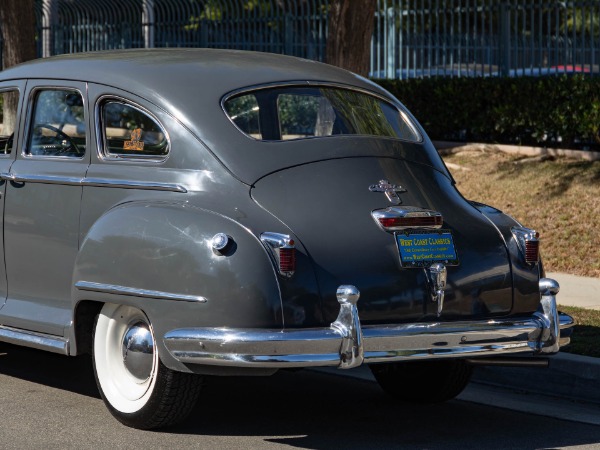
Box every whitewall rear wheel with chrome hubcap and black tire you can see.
[94,303,202,429]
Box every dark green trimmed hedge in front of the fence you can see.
[374,76,600,151]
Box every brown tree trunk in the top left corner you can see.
[0,0,35,69]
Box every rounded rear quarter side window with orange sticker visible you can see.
[100,100,169,159]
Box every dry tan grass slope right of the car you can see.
[444,151,600,277]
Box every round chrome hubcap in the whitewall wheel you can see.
[122,321,154,382]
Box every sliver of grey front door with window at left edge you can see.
[0,81,25,309]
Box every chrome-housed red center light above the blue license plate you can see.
[371,206,444,231]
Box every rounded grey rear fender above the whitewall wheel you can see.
[72,202,283,370]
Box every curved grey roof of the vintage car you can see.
[0,48,381,97]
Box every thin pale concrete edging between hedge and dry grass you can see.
[433,141,600,161]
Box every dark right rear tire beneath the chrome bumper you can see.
[369,360,472,403]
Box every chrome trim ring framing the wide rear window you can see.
[221,81,424,144]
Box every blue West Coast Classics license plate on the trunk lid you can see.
[396,230,458,267]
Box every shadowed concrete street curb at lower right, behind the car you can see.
[472,353,600,404]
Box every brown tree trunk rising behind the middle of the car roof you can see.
[325,0,377,76]
